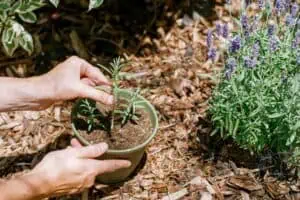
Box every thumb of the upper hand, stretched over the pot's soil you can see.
[78,84,113,104]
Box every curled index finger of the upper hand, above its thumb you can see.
[80,59,111,85]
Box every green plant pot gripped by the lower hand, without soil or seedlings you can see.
[71,89,158,184]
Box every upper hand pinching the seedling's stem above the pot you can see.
[32,56,113,109]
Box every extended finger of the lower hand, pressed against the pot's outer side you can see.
[90,160,131,174]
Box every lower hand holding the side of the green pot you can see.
[30,140,131,196]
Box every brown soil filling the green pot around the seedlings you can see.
[75,109,152,150]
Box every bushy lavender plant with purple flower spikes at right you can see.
[207,0,300,166]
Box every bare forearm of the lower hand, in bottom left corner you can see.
[0,174,48,200]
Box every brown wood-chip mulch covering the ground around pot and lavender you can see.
[0,0,300,200]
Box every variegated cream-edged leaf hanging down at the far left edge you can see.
[1,26,18,56]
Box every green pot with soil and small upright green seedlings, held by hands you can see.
[71,58,158,184]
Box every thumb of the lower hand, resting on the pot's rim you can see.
[76,143,108,158]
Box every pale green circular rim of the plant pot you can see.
[71,87,158,154]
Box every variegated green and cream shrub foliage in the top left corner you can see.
[0,0,103,56]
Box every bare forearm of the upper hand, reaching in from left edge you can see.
[0,77,49,112]
